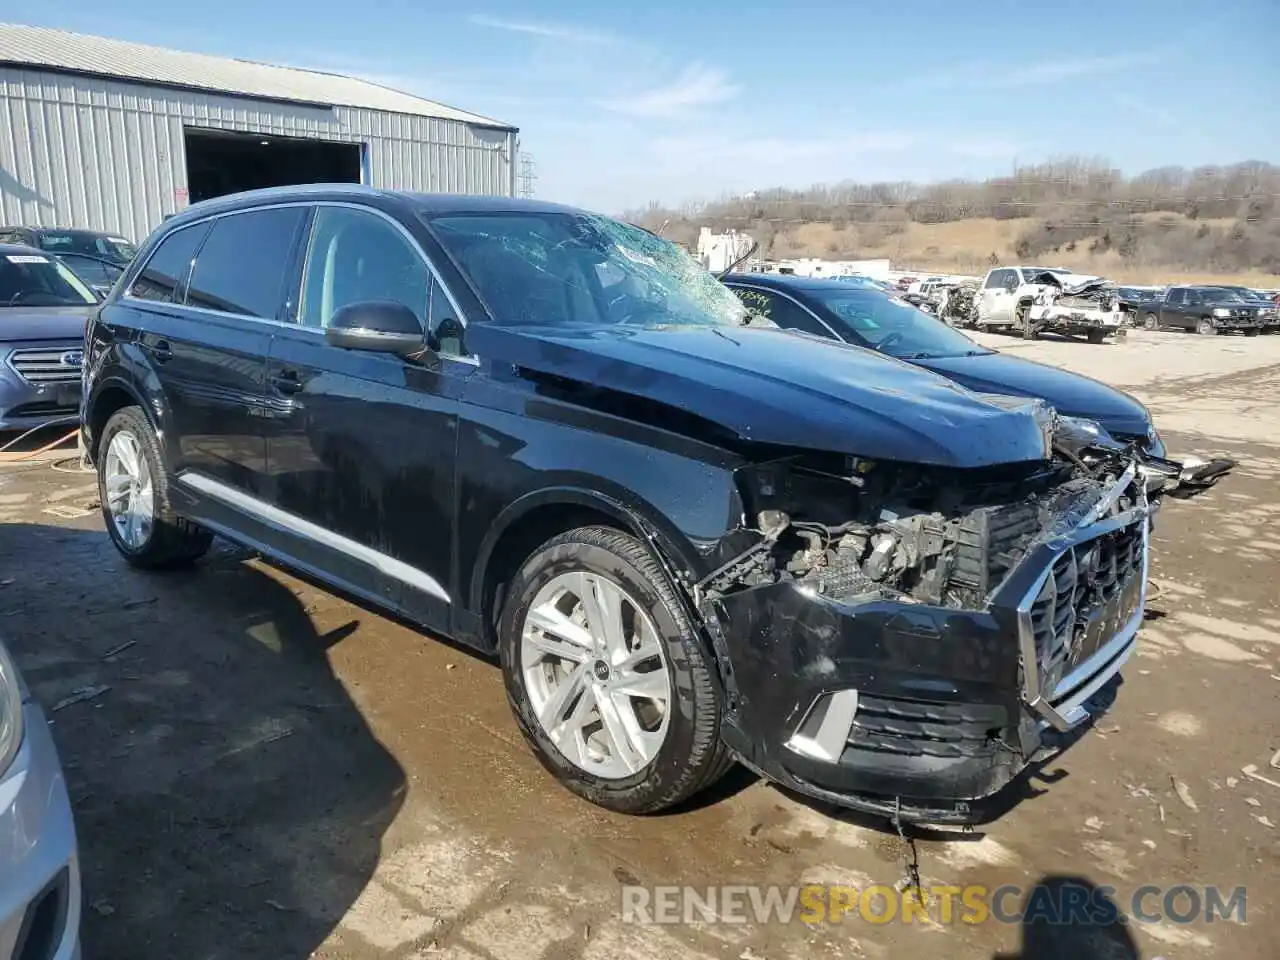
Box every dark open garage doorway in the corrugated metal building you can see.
[182,127,362,204]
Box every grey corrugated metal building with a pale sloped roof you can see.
[0,24,517,241]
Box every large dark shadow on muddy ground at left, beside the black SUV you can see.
[0,524,406,960]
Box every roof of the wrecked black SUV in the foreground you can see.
[164,183,586,235]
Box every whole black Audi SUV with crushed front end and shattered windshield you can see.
[83,187,1223,822]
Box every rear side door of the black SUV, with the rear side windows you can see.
[131,206,306,500]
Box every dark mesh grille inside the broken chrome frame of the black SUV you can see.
[1030,520,1146,694]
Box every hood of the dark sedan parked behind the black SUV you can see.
[913,353,1151,435]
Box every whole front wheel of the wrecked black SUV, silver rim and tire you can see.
[498,527,731,814]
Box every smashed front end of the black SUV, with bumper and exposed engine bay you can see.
[694,409,1151,822]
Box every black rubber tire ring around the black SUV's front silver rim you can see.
[498,539,716,809]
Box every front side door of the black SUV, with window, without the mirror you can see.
[264,205,475,630]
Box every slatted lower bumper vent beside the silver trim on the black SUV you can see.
[849,694,1007,758]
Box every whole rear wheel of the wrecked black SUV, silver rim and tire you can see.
[97,407,214,570]
